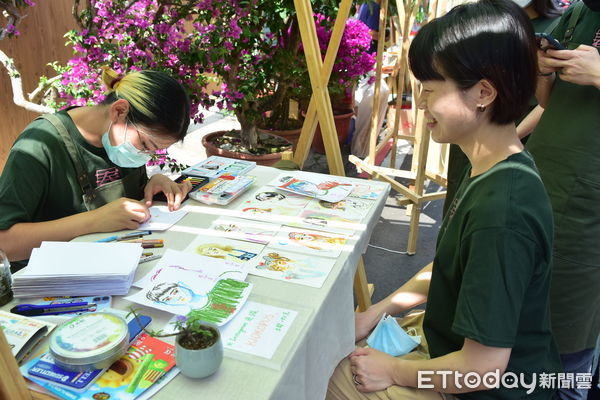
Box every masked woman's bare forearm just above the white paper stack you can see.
[0,212,101,261]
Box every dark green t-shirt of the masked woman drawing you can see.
[0,111,145,266]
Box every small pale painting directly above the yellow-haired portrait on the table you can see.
[210,217,281,244]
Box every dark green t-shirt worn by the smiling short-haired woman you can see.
[423,152,560,399]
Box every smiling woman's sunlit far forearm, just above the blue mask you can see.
[371,263,433,315]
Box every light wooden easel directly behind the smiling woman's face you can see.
[349,0,447,255]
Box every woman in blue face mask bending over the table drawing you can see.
[0,68,190,268]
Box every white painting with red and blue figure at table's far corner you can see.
[271,172,354,202]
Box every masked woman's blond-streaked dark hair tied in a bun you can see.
[101,67,190,140]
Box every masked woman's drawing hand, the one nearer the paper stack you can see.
[90,197,150,232]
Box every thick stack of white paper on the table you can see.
[13,242,143,297]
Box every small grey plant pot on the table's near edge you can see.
[175,323,223,378]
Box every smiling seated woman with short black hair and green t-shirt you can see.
[327,0,560,400]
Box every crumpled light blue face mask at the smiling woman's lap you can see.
[367,314,421,357]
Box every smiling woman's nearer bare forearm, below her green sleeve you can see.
[394,339,512,393]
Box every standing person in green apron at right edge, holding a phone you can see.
[527,0,600,399]
